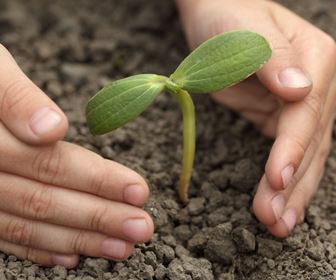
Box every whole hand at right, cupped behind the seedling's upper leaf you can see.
[177,0,336,237]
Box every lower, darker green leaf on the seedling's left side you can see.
[86,74,167,135]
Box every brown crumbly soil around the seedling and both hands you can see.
[0,0,336,280]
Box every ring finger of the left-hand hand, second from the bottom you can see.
[0,212,134,260]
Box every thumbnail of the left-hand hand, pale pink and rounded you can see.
[30,107,62,136]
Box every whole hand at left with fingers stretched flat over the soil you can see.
[0,45,153,267]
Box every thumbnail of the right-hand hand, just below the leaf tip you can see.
[278,68,312,88]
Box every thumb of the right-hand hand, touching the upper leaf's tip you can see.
[257,28,313,101]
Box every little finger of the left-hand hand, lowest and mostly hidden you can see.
[0,239,79,268]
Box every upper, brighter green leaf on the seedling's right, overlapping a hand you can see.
[170,30,272,93]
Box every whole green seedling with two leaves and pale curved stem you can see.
[86,30,272,203]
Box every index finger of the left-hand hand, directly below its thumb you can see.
[0,124,149,205]
